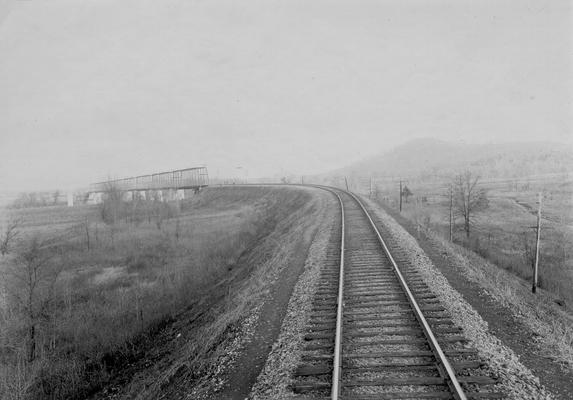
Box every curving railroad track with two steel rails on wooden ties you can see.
[293,188,503,400]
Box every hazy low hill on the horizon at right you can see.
[327,138,573,178]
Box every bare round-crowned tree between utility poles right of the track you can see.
[453,171,489,238]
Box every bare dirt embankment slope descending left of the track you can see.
[89,187,330,399]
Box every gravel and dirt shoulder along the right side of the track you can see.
[366,200,573,399]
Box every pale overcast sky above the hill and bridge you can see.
[0,0,573,190]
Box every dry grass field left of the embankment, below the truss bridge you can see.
[0,187,318,399]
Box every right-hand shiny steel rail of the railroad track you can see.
[346,191,467,400]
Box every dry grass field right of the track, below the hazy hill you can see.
[370,175,573,308]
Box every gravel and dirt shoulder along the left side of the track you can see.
[203,188,332,400]
